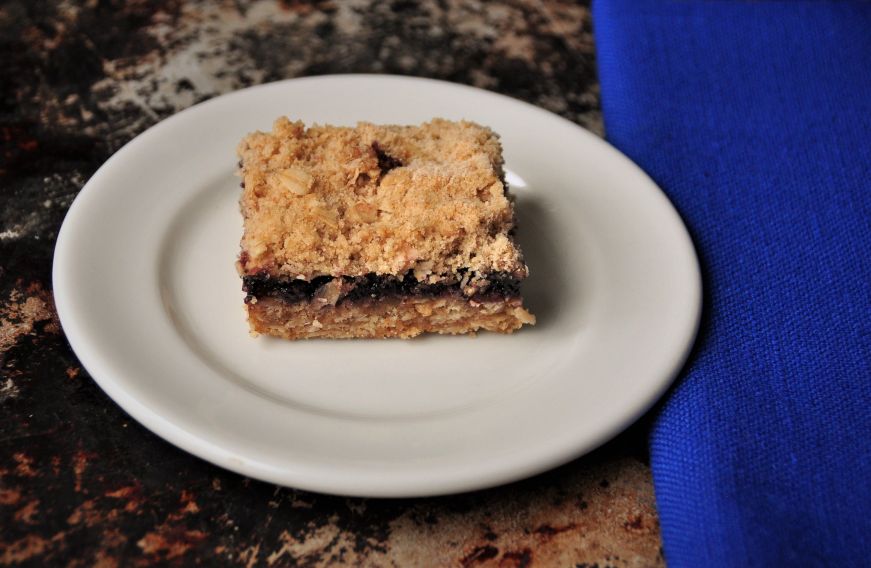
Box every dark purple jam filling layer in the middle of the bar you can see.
[242,272,520,303]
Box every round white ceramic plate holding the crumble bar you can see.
[53,76,701,496]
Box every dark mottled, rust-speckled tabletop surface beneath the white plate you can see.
[0,0,663,567]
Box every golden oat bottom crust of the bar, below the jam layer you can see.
[248,296,535,339]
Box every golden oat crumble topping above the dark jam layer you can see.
[238,118,527,282]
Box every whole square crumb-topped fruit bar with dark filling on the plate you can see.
[237,118,535,339]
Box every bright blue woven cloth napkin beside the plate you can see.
[593,0,871,567]
